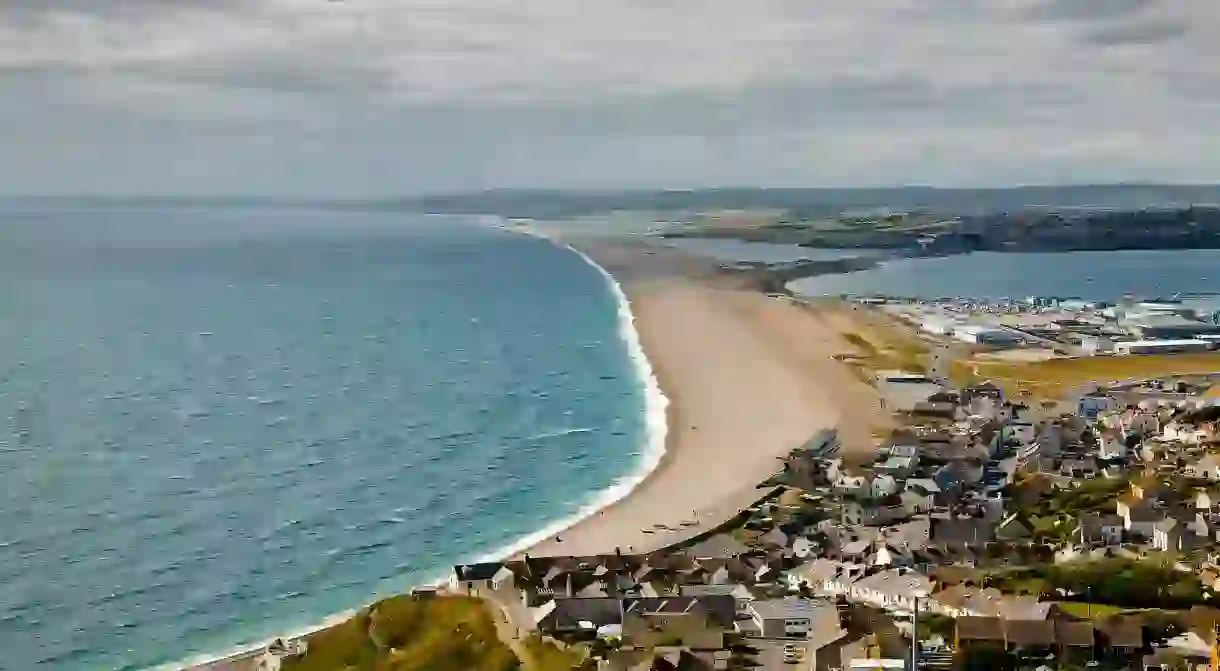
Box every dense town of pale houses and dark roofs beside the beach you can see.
[402,373,1220,671]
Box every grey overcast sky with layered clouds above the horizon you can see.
[0,0,1220,198]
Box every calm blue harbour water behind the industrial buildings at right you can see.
[789,249,1220,301]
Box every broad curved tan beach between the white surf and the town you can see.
[528,244,883,555]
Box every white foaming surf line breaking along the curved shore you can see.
[161,217,670,671]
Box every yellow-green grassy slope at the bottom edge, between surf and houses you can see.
[284,595,519,671]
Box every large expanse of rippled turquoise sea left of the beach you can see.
[0,206,647,670]
